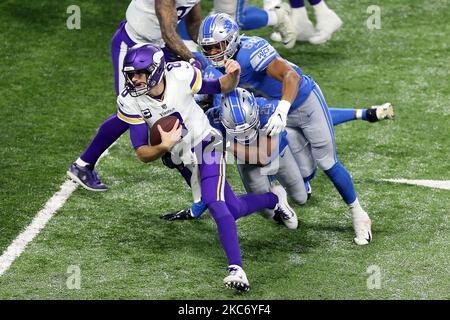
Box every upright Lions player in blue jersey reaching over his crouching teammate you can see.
[197,14,372,245]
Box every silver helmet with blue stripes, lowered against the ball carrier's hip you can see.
[220,88,260,143]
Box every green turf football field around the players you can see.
[0,0,450,299]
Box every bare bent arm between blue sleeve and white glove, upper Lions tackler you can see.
[266,57,301,104]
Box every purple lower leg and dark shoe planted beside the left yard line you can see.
[67,115,128,192]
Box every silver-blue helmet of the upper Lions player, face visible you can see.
[198,13,240,68]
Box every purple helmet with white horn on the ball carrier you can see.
[122,43,166,97]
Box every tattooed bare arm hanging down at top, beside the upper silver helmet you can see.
[155,0,193,61]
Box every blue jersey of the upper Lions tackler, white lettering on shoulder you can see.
[233,36,314,110]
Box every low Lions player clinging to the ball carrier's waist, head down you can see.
[161,88,393,221]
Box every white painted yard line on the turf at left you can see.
[0,146,112,276]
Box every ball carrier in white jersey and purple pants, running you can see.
[117,44,298,291]
